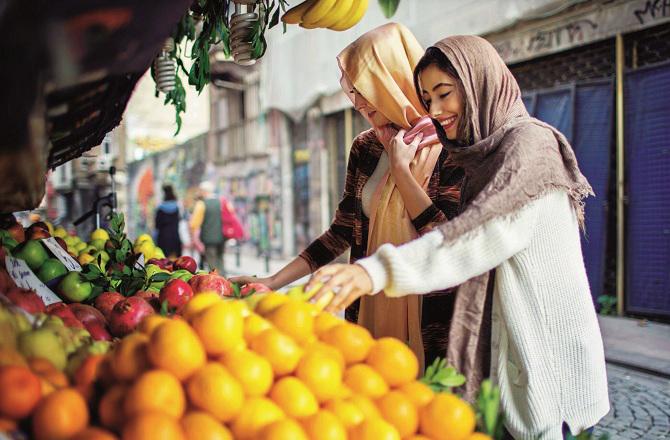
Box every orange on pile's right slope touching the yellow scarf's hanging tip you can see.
[366,338,419,387]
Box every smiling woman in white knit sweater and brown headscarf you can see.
[310,36,609,440]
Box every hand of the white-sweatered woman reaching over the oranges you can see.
[305,264,374,313]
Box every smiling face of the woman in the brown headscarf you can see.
[419,64,464,140]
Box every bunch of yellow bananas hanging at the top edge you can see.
[282,0,368,31]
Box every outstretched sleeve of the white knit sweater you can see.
[356,196,546,297]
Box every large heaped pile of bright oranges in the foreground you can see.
[81,293,487,440]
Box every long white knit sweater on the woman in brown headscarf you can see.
[357,192,609,440]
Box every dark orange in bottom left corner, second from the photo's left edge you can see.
[32,388,88,440]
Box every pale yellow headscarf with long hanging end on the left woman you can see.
[337,23,442,367]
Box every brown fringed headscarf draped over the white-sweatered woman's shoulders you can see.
[422,36,593,401]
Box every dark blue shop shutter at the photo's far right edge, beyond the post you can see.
[624,62,670,316]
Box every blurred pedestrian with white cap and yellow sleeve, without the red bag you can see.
[190,182,226,275]
